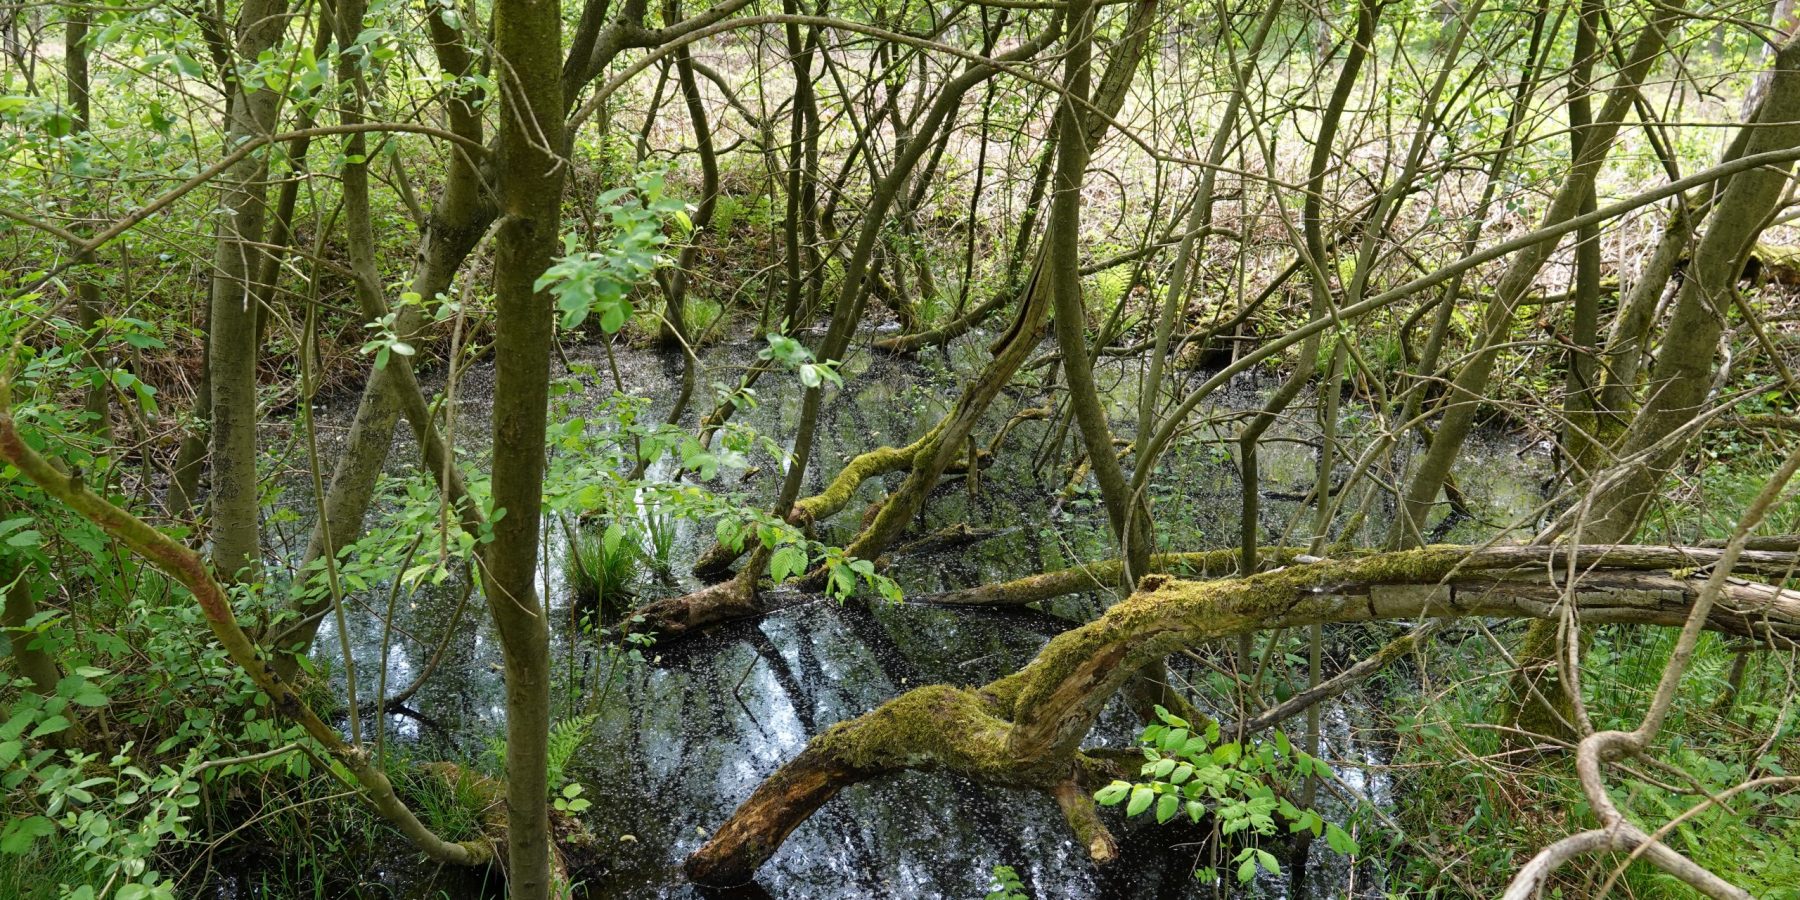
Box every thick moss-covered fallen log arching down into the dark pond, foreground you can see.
[686,545,1800,886]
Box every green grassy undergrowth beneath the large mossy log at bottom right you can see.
[1390,626,1800,900]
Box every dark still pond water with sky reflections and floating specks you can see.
[228,325,1544,898]
